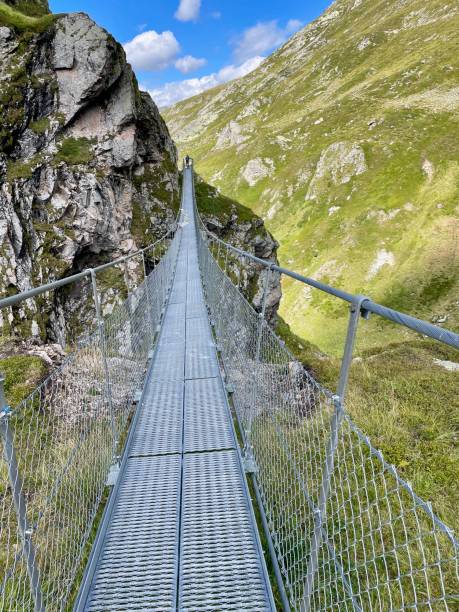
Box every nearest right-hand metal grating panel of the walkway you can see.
[179,451,272,612]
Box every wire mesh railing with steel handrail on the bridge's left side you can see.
[0,219,181,611]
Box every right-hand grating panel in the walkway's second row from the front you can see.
[184,378,235,453]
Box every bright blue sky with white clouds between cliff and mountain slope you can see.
[50,0,331,106]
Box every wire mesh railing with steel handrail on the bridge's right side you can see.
[197,171,459,611]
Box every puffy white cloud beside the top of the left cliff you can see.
[124,30,180,72]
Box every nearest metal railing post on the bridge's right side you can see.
[300,296,368,612]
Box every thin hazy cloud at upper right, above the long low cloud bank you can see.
[233,19,302,62]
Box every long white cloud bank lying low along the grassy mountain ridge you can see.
[144,56,265,108]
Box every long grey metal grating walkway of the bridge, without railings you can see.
[77,170,275,612]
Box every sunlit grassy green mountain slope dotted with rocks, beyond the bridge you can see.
[163,0,459,352]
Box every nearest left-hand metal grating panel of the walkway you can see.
[86,455,181,612]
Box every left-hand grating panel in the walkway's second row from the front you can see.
[129,379,184,457]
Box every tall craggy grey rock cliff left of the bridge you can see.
[0,0,179,344]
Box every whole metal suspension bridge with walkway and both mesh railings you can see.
[0,160,459,612]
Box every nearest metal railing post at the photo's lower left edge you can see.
[0,373,45,612]
